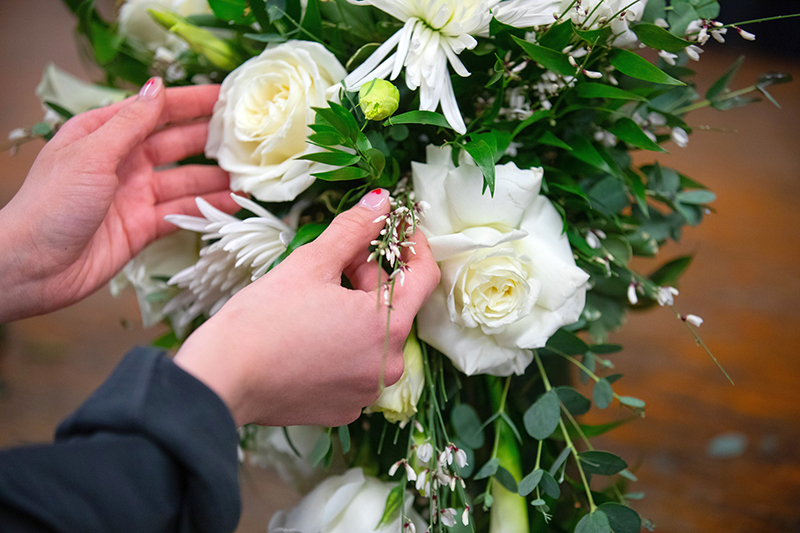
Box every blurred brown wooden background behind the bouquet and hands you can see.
[0,0,800,533]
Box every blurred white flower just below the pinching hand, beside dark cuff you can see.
[249,426,330,494]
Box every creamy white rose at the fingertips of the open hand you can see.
[206,41,347,202]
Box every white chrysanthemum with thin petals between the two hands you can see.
[164,194,294,333]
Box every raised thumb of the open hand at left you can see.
[91,77,165,162]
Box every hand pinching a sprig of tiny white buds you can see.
[175,189,439,426]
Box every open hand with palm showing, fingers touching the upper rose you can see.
[0,78,237,323]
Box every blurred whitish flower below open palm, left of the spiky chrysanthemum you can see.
[109,231,200,328]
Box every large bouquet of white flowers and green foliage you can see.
[11,0,790,533]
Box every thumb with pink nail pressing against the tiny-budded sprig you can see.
[313,189,391,279]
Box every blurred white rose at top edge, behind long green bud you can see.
[118,0,212,52]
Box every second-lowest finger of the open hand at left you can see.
[153,165,230,204]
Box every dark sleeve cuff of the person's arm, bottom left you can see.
[0,348,241,533]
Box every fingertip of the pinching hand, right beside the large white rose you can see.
[393,229,441,316]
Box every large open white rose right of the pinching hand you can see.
[412,146,589,376]
